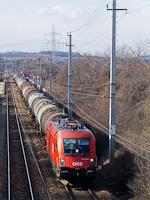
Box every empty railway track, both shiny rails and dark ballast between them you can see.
[6,82,34,200]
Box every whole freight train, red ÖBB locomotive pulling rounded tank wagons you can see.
[14,74,97,179]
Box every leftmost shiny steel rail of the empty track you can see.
[6,82,11,200]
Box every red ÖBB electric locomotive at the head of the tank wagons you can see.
[47,118,97,178]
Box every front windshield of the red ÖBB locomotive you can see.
[64,138,90,156]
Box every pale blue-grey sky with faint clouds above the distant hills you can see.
[0,0,150,53]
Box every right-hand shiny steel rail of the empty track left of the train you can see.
[10,81,34,200]
